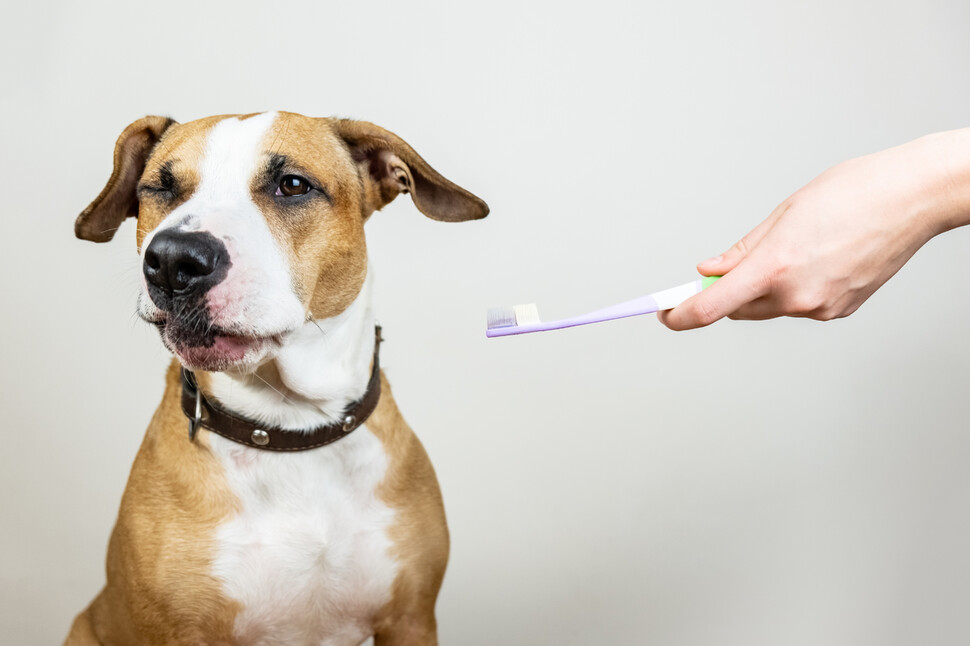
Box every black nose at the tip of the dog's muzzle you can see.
[143,229,230,306]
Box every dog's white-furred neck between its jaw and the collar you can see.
[207,272,375,430]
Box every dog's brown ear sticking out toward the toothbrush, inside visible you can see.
[334,119,488,222]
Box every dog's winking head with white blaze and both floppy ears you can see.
[76,113,488,370]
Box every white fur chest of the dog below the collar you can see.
[212,426,397,644]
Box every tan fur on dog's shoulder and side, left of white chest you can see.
[67,368,237,645]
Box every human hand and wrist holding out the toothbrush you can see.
[657,129,970,330]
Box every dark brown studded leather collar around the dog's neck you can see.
[182,325,383,451]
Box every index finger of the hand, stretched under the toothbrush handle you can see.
[657,265,768,330]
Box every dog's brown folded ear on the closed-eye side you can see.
[74,117,175,242]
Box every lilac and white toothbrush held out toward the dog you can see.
[485,276,720,338]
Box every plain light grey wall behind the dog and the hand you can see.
[0,0,970,646]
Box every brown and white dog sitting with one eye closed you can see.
[66,112,488,646]
